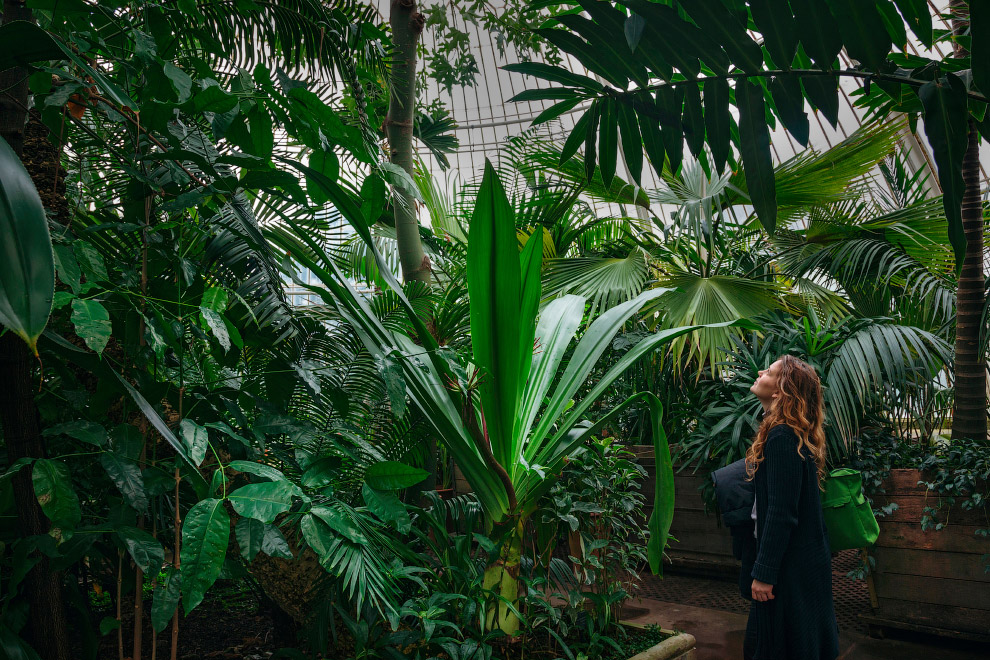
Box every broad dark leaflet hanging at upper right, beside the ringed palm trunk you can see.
[918,73,969,269]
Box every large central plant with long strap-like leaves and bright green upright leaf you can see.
[273,159,752,634]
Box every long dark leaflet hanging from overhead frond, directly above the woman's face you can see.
[736,80,777,233]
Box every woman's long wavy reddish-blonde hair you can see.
[746,355,825,486]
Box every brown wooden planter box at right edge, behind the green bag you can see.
[863,470,990,641]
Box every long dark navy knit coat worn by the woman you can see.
[740,424,839,660]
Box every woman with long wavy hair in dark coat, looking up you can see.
[743,355,839,660]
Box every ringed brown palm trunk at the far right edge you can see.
[950,0,987,441]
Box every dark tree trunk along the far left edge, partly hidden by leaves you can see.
[0,0,69,660]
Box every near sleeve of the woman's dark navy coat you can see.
[752,426,804,584]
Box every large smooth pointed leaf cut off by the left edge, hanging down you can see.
[0,133,53,355]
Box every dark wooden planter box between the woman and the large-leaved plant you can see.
[630,445,740,580]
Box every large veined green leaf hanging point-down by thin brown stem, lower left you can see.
[179,498,230,615]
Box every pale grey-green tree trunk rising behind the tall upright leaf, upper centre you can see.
[385,0,431,282]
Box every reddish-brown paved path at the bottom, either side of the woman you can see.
[624,598,987,660]
